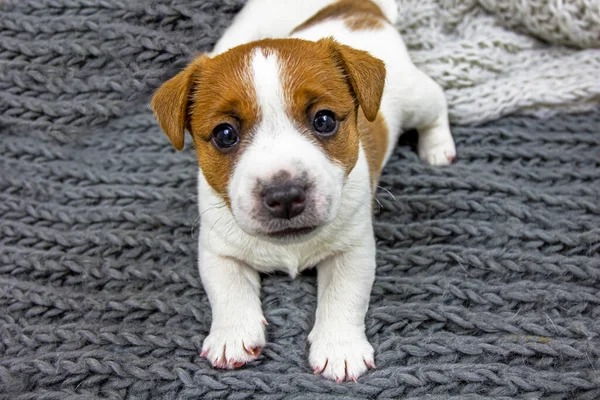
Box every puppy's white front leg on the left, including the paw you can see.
[199,249,266,369]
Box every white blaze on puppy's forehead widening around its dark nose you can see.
[229,49,344,238]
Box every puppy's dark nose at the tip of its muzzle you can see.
[263,183,306,219]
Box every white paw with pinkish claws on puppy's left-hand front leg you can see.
[200,319,267,369]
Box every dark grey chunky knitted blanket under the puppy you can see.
[0,0,600,400]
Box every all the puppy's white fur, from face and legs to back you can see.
[198,0,455,380]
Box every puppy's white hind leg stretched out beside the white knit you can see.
[403,68,456,165]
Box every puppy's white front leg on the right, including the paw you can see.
[308,228,375,382]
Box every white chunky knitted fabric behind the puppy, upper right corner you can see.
[397,0,600,124]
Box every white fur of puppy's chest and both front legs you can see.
[198,149,375,380]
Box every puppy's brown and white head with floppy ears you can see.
[152,39,385,239]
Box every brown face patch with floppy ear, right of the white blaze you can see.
[251,39,387,175]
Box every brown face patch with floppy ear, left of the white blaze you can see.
[152,45,260,206]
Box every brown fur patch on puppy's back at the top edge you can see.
[292,0,387,33]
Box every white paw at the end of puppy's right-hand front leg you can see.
[308,327,375,383]
